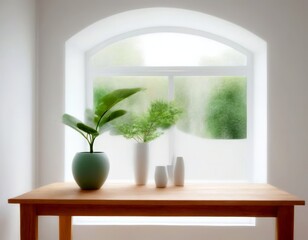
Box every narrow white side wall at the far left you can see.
[0,0,35,240]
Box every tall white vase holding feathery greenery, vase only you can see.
[134,143,149,185]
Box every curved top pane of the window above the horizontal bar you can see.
[91,33,247,68]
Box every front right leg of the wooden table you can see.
[276,206,294,240]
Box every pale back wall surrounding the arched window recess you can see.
[38,0,308,240]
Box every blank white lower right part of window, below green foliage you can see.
[174,130,250,182]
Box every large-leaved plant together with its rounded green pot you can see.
[62,88,142,189]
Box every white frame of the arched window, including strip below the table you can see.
[74,27,255,226]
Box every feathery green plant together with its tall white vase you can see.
[115,100,182,185]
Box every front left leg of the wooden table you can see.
[20,204,38,240]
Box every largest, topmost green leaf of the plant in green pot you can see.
[95,88,144,123]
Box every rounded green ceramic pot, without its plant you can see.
[72,152,109,190]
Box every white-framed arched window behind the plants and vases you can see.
[86,28,253,182]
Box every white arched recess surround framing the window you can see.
[65,8,267,182]
